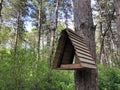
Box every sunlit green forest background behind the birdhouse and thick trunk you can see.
[0,0,120,90]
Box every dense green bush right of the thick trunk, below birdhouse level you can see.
[98,65,120,90]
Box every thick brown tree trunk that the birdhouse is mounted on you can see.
[73,0,98,90]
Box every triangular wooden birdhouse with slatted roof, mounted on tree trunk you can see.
[52,29,96,70]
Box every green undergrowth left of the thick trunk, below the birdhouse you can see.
[0,46,74,90]
